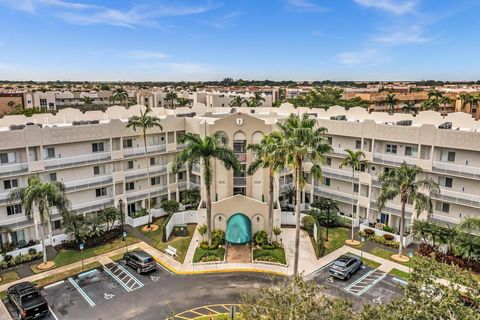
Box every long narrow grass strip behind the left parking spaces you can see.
[31,235,139,273]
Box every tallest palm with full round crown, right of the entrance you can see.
[278,114,332,275]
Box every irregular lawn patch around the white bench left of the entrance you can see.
[142,221,197,263]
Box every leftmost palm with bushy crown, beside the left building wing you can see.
[8,175,69,264]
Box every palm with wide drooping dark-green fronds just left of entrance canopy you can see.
[173,132,240,241]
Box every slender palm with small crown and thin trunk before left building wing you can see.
[127,108,163,229]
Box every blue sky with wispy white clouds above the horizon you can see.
[0,0,480,81]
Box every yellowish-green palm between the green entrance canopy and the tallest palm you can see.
[247,132,285,239]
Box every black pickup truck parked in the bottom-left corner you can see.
[7,282,49,319]
